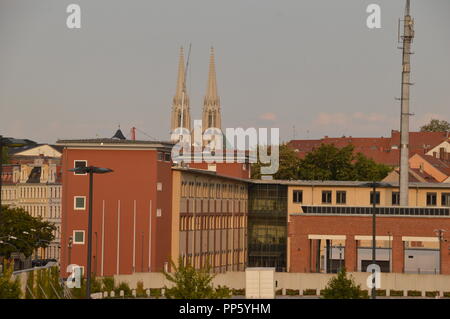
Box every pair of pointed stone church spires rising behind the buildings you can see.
[171,47,222,139]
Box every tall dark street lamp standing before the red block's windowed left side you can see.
[69,166,113,299]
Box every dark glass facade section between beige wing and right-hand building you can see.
[248,184,287,271]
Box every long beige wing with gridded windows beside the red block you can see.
[171,168,248,272]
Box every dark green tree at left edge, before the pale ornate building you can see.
[0,206,56,258]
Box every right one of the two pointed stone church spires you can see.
[202,47,222,131]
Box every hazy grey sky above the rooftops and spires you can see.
[0,0,450,143]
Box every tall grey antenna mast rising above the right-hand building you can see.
[399,0,414,206]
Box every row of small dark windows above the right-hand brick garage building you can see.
[292,190,450,207]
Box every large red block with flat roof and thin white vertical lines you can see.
[58,139,172,276]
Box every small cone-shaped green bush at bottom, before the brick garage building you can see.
[322,268,367,299]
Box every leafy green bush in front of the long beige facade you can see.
[164,258,231,299]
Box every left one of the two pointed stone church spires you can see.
[170,47,191,138]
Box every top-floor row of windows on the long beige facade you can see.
[181,181,247,199]
